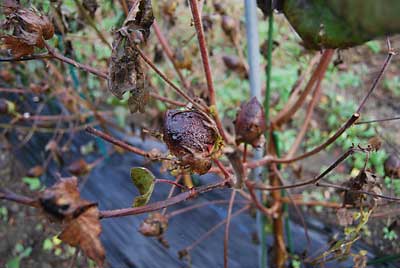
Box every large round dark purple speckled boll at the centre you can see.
[163,110,222,174]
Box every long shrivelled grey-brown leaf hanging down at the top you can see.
[108,0,154,113]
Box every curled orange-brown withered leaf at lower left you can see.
[38,177,105,267]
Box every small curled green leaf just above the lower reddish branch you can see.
[131,167,155,207]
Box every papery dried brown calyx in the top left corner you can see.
[0,1,54,58]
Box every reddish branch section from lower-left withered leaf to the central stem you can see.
[100,181,226,218]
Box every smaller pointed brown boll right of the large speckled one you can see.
[235,97,267,147]
